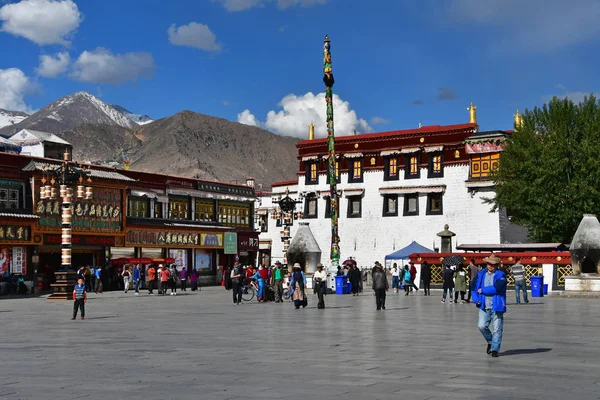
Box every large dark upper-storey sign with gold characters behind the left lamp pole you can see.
[36,187,122,232]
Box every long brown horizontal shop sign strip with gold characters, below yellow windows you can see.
[125,230,223,248]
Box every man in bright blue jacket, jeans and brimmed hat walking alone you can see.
[473,254,506,357]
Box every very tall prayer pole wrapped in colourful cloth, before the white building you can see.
[323,35,340,267]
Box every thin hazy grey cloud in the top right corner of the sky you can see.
[433,0,600,52]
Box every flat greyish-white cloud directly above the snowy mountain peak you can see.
[70,47,154,84]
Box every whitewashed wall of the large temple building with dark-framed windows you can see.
[258,164,500,266]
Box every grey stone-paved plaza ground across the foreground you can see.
[0,287,600,400]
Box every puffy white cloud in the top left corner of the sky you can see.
[0,0,83,46]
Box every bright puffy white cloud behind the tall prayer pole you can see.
[238,92,373,138]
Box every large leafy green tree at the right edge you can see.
[488,95,600,243]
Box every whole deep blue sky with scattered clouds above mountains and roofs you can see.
[0,0,600,137]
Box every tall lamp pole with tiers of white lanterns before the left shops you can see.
[40,149,93,270]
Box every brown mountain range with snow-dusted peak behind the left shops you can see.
[0,92,299,187]
